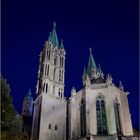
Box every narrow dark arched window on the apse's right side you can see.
[114,102,121,134]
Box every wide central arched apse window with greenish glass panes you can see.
[96,97,107,134]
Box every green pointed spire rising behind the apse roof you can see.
[87,48,97,72]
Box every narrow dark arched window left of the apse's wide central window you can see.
[80,99,86,136]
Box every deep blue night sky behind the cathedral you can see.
[1,0,139,129]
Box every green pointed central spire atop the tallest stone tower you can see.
[48,22,59,47]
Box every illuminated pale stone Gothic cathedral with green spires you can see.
[31,23,133,140]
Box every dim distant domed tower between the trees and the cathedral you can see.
[22,90,33,140]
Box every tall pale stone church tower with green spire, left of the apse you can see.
[32,23,66,140]
